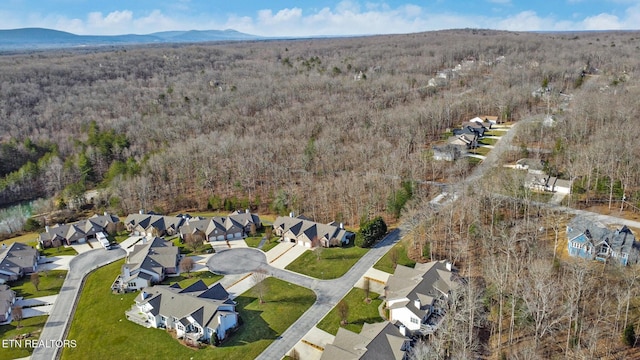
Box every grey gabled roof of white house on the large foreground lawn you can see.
[136,280,235,329]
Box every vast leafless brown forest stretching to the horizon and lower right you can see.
[0,29,640,359]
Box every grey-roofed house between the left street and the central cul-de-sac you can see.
[111,237,180,292]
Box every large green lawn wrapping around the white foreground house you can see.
[62,261,315,360]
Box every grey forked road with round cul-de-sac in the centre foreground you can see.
[207,230,401,360]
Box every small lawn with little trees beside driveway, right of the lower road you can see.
[318,288,384,335]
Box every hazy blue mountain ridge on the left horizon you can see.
[0,28,261,50]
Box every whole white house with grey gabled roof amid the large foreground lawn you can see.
[126,280,238,343]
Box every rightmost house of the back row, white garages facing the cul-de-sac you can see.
[273,213,355,248]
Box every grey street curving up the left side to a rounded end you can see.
[31,247,126,360]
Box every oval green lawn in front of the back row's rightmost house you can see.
[286,246,368,279]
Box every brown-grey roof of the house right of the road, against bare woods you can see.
[385,260,460,318]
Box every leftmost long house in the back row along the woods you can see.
[38,212,120,248]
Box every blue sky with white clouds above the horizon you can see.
[0,0,640,37]
